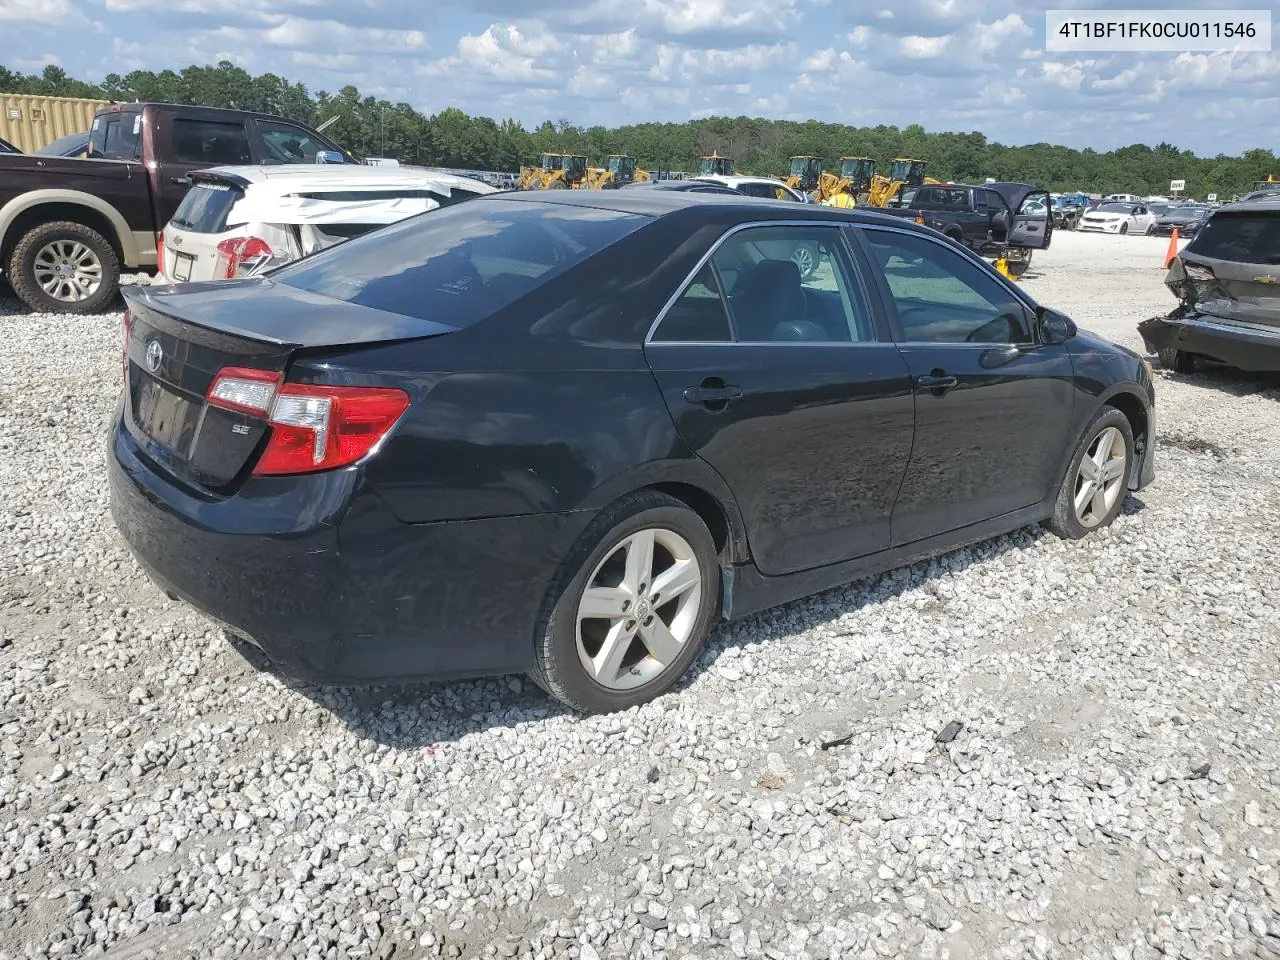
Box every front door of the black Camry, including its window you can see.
[859,227,1073,545]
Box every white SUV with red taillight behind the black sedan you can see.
[156,164,495,283]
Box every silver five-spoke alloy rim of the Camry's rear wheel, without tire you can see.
[576,527,703,690]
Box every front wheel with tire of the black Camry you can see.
[1044,407,1134,540]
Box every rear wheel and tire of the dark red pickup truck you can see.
[9,220,120,314]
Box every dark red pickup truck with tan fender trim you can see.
[0,104,357,314]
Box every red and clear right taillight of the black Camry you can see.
[253,383,408,476]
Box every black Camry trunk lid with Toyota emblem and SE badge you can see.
[124,279,453,494]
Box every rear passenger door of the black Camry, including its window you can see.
[645,224,915,576]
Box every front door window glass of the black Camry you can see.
[867,229,1032,343]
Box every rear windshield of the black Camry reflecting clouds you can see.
[271,197,649,326]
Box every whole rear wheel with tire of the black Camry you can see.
[530,490,721,713]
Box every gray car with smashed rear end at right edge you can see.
[1138,196,1280,374]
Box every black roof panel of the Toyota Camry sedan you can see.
[481,189,933,233]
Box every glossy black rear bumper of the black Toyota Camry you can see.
[109,421,588,682]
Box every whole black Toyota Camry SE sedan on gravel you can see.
[110,191,1155,710]
